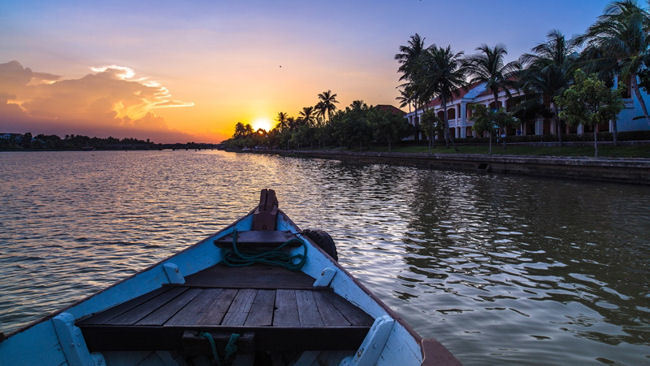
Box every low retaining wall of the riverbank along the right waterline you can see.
[249,150,650,185]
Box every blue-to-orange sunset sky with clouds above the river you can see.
[0,0,609,142]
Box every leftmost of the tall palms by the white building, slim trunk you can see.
[395,33,426,142]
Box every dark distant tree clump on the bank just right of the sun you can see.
[222,90,413,151]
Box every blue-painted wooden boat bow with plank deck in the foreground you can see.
[0,190,459,366]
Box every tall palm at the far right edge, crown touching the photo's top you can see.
[577,0,650,123]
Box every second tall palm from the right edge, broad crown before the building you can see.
[520,30,577,145]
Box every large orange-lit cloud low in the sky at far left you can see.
[0,61,194,141]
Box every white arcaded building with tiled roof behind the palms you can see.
[406,80,650,139]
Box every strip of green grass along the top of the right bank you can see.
[370,144,650,158]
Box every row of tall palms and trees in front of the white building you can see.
[395,0,650,154]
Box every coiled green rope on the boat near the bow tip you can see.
[222,230,307,271]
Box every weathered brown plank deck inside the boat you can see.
[77,265,372,351]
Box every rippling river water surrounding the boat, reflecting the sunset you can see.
[0,151,650,365]
